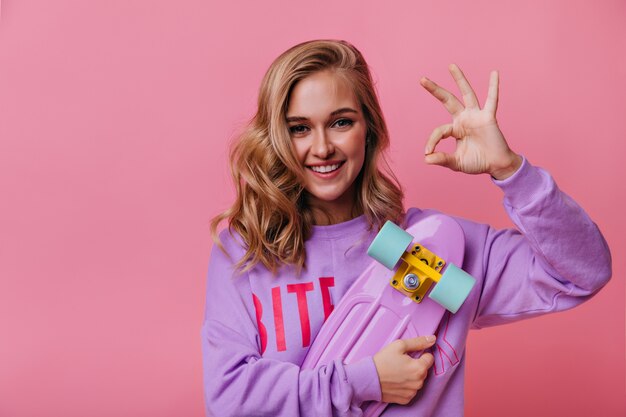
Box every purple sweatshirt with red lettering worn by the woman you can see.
[202,160,611,417]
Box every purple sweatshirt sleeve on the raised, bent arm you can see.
[464,159,612,328]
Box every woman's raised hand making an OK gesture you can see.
[420,64,522,180]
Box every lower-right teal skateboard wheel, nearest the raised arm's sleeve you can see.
[429,264,476,313]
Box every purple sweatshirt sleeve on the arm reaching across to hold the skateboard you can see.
[201,233,381,417]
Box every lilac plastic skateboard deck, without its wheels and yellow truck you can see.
[302,214,471,417]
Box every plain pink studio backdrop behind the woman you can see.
[0,0,626,417]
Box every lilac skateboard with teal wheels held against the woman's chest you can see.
[302,214,475,417]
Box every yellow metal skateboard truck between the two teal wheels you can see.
[390,243,446,304]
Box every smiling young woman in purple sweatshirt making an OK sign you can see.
[202,40,611,416]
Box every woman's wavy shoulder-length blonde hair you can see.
[210,40,404,273]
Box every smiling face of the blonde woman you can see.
[287,71,367,221]
